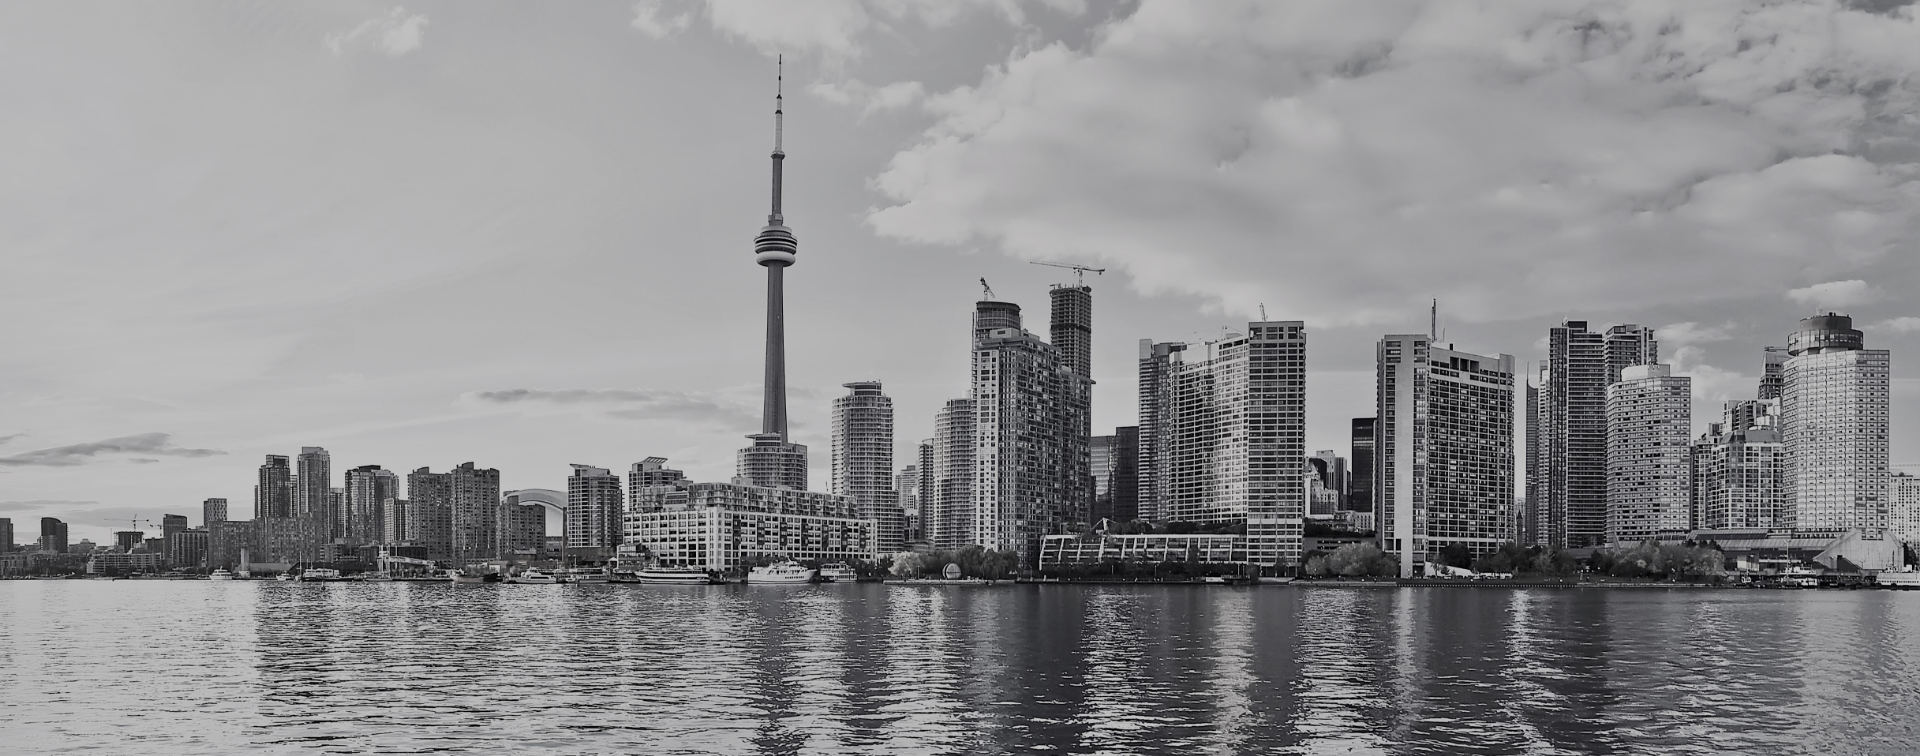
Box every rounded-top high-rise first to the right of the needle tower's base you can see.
[828,380,906,555]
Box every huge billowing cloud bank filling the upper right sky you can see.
[868,0,1920,324]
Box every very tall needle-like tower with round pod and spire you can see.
[739,63,806,491]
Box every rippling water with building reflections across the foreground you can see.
[0,581,1920,754]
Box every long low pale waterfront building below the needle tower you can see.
[624,482,876,570]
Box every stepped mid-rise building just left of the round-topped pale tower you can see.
[1692,399,1786,530]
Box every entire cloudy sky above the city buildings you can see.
[0,0,1920,541]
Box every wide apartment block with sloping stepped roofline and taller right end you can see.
[1139,320,1308,568]
